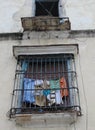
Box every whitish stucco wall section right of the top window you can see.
[65,0,95,30]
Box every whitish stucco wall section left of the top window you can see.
[0,0,35,33]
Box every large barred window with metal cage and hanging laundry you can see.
[10,54,81,116]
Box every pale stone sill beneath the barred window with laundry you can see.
[16,111,77,127]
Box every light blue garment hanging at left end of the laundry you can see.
[23,78,35,103]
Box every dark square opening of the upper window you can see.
[36,1,58,17]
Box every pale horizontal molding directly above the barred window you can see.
[13,44,78,58]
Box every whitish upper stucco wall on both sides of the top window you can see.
[0,0,95,33]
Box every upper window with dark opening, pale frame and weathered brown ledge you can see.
[21,0,71,31]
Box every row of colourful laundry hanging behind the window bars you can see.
[23,77,68,106]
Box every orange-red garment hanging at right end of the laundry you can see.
[60,77,69,98]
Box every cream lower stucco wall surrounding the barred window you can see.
[0,35,95,130]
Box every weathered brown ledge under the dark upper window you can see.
[21,16,71,31]
